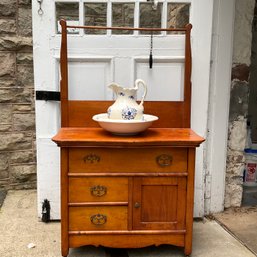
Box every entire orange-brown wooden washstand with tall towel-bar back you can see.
[52,20,204,256]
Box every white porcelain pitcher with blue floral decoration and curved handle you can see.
[107,79,147,120]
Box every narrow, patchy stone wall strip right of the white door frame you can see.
[225,0,255,208]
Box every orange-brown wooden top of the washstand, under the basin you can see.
[52,127,205,147]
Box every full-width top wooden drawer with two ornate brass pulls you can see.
[69,147,187,173]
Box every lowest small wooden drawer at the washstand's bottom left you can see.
[69,206,128,231]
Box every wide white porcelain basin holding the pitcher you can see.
[92,113,158,136]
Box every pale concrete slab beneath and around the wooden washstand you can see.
[0,190,255,257]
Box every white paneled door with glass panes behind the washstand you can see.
[32,0,213,219]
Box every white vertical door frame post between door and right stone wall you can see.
[204,0,235,214]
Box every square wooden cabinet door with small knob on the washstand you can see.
[132,177,186,230]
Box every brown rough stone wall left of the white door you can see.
[0,0,36,191]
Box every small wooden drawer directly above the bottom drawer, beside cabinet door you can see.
[69,177,128,203]
